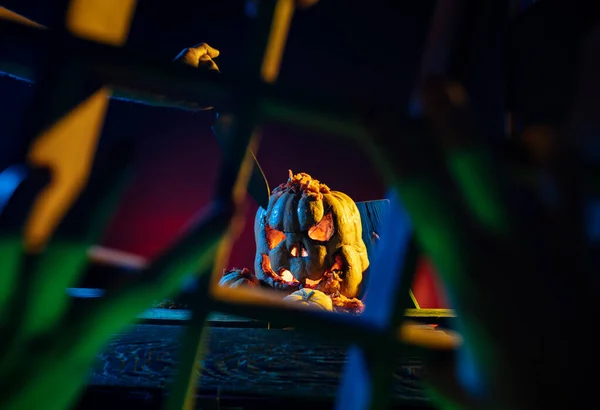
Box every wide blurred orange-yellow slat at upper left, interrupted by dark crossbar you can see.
[25,0,136,252]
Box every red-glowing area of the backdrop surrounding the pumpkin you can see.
[96,103,446,308]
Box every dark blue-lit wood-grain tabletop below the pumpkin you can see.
[90,325,428,405]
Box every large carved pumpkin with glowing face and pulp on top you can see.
[254,171,369,298]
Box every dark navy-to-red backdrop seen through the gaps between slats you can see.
[8,0,594,307]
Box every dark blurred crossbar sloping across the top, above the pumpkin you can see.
[0,17,380,142]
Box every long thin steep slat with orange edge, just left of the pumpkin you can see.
[167,0,295,410]
